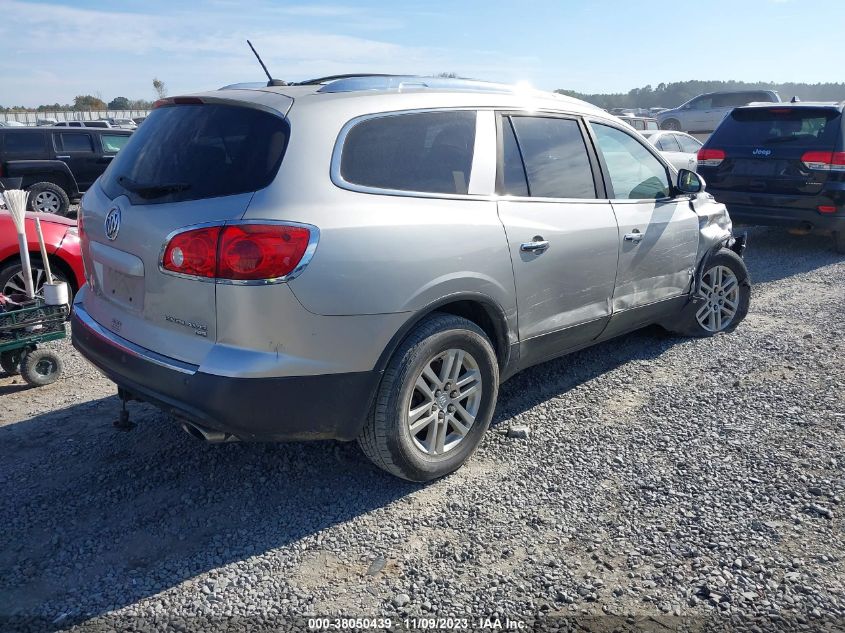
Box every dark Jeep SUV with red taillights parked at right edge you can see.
[698,101,845,253]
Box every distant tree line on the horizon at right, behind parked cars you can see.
[555,81,845,110]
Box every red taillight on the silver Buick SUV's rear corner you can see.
[161,224,317,281]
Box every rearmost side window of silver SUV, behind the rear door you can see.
[340,111,475,194]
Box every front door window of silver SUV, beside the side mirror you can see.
[591,123,671,200]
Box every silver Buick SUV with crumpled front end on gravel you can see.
[73,76,750,481]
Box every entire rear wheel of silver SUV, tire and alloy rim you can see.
[358,314,499,482]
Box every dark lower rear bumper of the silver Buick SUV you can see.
[71,304,381,441]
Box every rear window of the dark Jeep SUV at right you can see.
[707,108,842,149]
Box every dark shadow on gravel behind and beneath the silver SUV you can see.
[0,397,420,628]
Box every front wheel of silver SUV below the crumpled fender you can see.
[676,248,751,337]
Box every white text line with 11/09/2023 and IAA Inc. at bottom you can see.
[308,617,528,631]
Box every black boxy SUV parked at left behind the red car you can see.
[0,127,132,215]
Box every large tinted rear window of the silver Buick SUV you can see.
[101,104,289,204]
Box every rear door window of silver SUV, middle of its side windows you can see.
[511,116,596,198]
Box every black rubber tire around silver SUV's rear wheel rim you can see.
[358,313,499,482]
